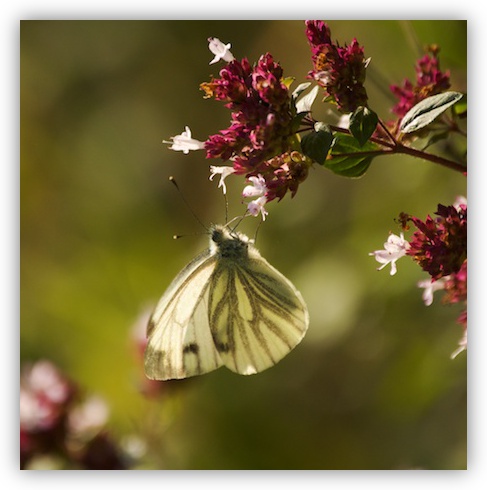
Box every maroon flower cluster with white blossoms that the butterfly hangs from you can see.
[165,38,311,219]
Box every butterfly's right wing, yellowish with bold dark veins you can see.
[209,248,309,374]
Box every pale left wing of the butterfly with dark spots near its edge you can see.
[145,250,222,380]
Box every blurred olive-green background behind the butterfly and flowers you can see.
[20,19,467,469]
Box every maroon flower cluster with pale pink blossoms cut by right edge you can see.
[369,198,467,357]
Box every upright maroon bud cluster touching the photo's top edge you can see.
[306,20,369,113]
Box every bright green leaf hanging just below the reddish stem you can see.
[325,134,379,177]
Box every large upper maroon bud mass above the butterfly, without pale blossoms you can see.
[201,53,293,168]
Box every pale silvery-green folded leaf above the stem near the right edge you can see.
[399,92,463,133]
